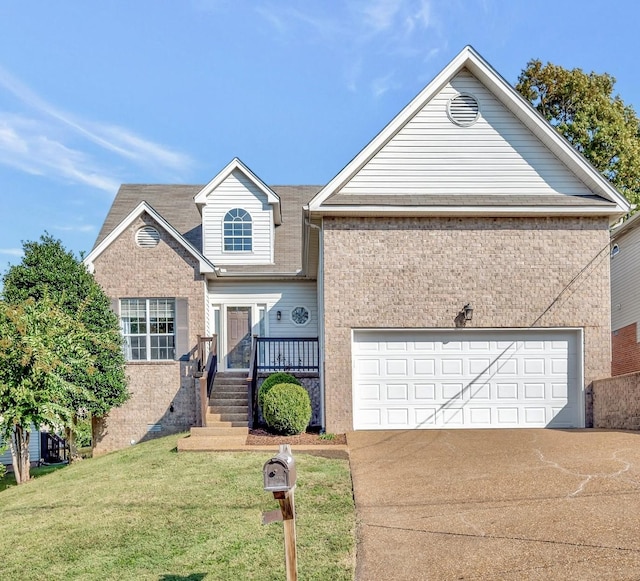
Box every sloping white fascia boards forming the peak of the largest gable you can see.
[309,46,630,215]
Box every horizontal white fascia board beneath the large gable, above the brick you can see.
[313,206,620,223]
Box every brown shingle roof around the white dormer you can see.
[94,184,322,273]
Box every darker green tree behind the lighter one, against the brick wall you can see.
[3,234,129,459]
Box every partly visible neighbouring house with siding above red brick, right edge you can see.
[611,214,640,376]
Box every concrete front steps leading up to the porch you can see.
[178,372,249,452]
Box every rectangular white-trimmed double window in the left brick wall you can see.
[120,299,176,361]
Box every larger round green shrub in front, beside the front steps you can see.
[262,383,311,436]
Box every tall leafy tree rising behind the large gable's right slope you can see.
[516,60,640,204]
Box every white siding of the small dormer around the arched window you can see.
[202,170,273,266]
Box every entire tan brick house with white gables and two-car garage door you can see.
[85,47,629,450]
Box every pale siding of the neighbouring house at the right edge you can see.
[611,224,640,340]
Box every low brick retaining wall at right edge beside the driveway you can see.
[592,373,640,430]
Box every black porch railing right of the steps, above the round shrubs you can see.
[247,337,320,428]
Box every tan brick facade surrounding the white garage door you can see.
[323,217,610,432]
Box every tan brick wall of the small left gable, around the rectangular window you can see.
[94,214,205,454]
